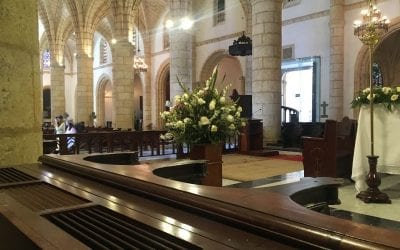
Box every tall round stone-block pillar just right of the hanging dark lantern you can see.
[251,0,282,143]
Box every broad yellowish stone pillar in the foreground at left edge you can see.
[0,0,43,166]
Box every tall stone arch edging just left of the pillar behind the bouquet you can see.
[154,59,170,128]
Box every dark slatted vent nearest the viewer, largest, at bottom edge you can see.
[43,206,201,249]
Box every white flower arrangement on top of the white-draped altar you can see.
[351,87,400,111]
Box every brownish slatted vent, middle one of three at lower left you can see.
[0,182,89,212]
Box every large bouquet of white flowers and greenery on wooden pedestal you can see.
[161,67,245,144]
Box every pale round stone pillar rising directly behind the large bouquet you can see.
[169,0,192,101]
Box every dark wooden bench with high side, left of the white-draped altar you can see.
[303,117,357,179]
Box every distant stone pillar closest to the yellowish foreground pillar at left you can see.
[50,63,66,119]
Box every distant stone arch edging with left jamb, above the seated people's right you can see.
[95,74,112,126]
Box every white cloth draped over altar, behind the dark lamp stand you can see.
[351,104,400,191]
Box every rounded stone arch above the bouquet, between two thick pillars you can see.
[199,49,245,94]
